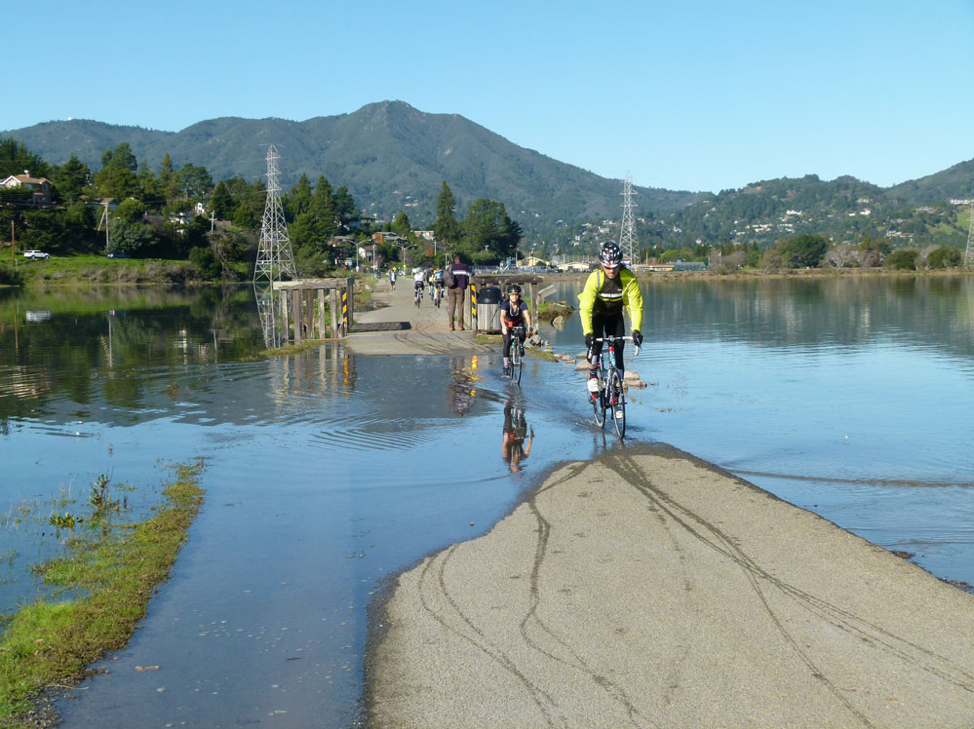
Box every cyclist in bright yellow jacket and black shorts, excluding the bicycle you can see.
[578,243,643,401]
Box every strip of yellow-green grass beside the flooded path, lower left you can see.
[0,460,203,729]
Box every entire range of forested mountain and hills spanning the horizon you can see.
[0,100,974,245]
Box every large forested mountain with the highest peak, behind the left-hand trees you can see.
[0,101,701,237]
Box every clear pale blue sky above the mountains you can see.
[7,0,974,191]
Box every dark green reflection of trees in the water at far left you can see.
[0,286,262,419]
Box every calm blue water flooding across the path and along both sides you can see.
[0,277,974,727]
